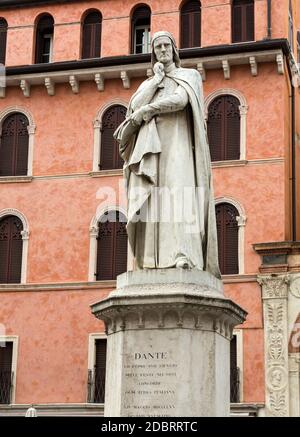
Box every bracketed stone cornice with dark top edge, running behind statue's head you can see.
[0,40,287,98]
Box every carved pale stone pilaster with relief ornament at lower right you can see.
[258,274,290,416]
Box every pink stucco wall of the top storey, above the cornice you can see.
[0,0,296,66]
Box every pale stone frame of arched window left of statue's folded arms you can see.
[93,98,128,173]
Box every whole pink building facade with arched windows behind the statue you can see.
[0,0,300,416]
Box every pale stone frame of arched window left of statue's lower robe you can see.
[88,205,133,283]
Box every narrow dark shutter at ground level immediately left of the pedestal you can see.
[94,339,107,403]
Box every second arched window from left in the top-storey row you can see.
[35,14,54,64]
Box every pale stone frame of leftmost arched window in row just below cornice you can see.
[0,106,36,182]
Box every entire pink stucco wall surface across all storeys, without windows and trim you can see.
[0,0,300,403]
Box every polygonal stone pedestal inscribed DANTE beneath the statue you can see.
[92,269,246,417]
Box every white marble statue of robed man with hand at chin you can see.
[115,31,220,277]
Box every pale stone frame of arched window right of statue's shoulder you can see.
[204,88,249,163]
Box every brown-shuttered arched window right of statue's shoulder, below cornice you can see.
[207,95,240,161]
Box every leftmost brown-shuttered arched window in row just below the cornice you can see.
[0,112,29,176]
